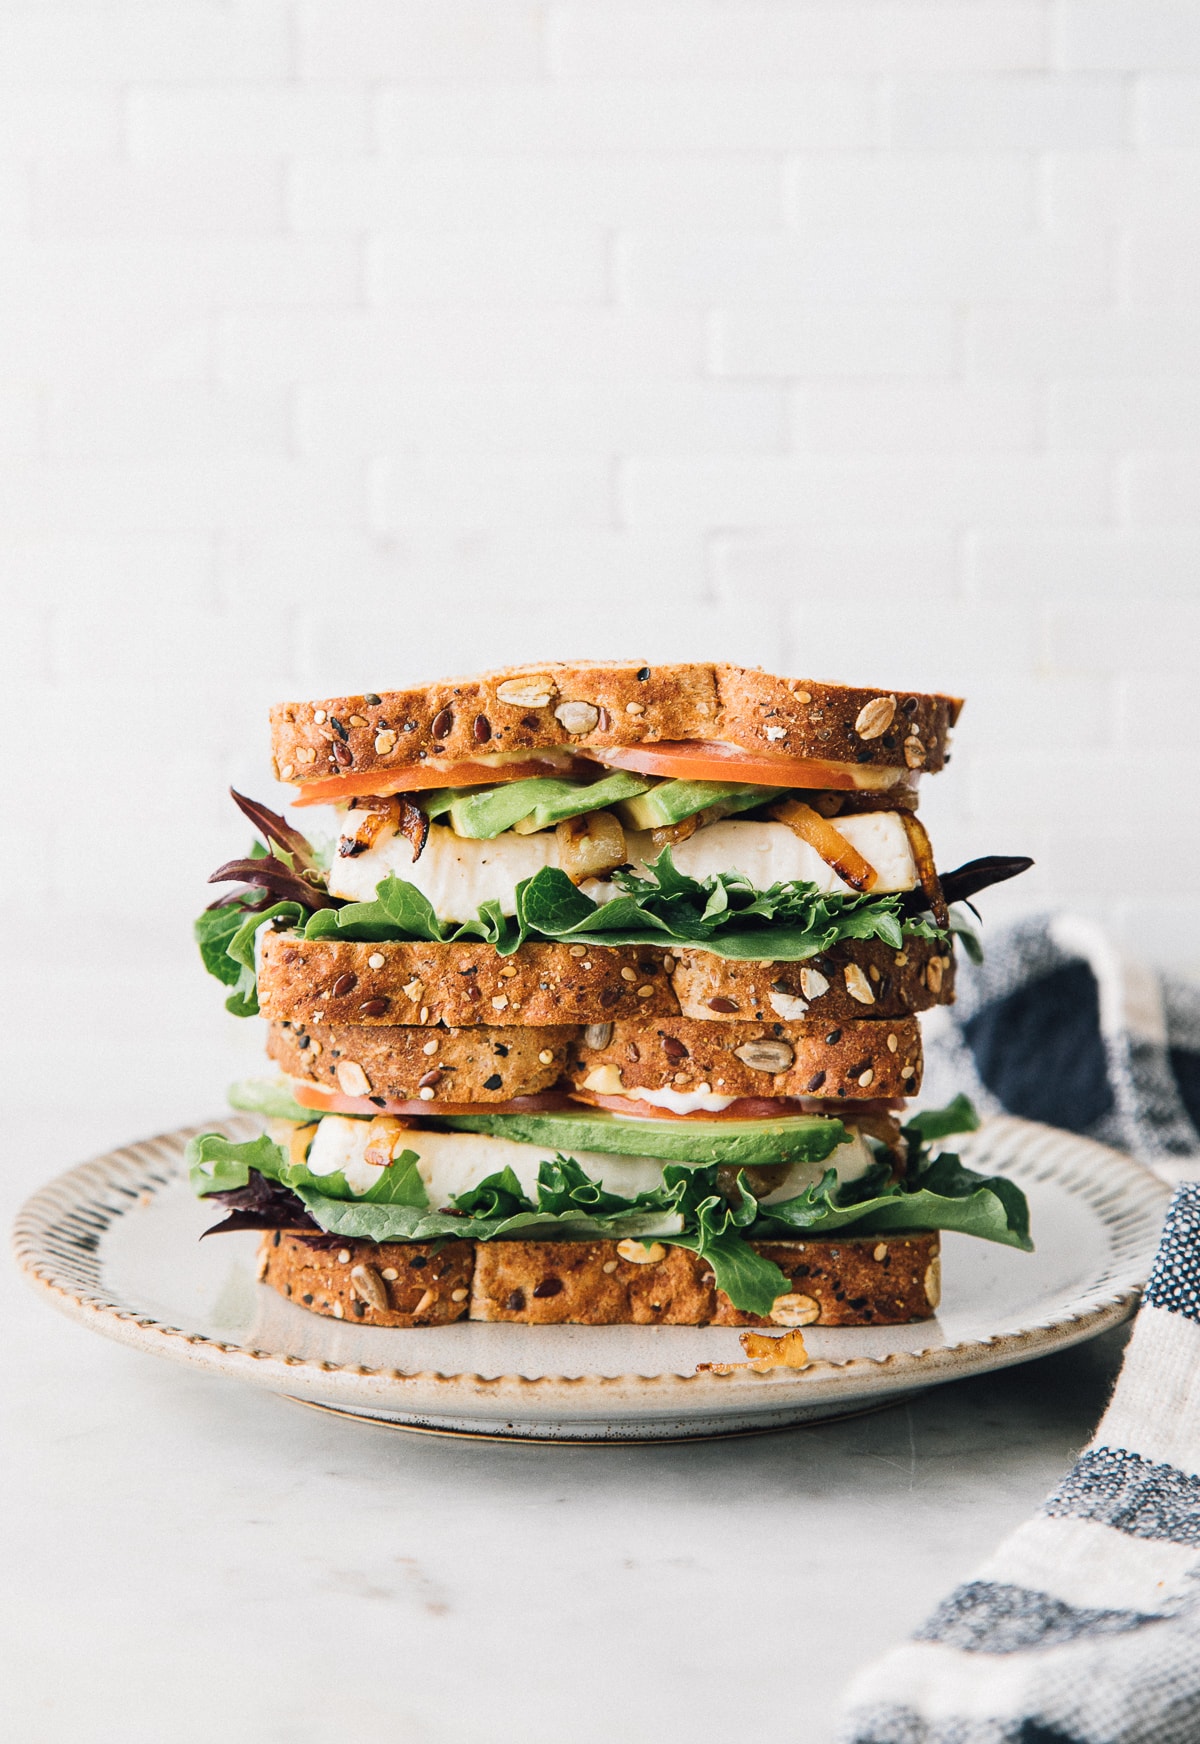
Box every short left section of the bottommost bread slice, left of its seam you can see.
[258,1230,474,1325]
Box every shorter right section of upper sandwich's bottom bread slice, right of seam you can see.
[672,938,954,1022]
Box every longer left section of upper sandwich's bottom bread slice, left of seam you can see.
[258,931,678,1027]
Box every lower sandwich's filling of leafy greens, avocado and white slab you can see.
[188,1099,1029,1313]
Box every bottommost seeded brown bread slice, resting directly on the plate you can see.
[258,1230,942,1325]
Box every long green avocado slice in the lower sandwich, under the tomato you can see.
[441,1107,849,1168]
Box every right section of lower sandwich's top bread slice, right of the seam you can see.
[567,1017,921,1099]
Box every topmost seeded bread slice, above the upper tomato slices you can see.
[270,661,963,787]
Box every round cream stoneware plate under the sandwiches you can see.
[16,1116,1169,1442]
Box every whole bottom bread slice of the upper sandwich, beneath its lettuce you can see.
[258,930,954,1027]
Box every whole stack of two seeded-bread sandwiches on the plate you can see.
[190,661,1029,1327]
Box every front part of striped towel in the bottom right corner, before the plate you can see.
[842,1182,1200,1744]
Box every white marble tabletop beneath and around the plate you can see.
[0,1095,1123,1744]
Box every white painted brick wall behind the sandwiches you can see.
[0,0,1200,1005]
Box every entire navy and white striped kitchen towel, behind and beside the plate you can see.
[841,917,1200,1744]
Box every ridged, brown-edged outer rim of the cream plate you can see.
[12,1114,1170,1416]
